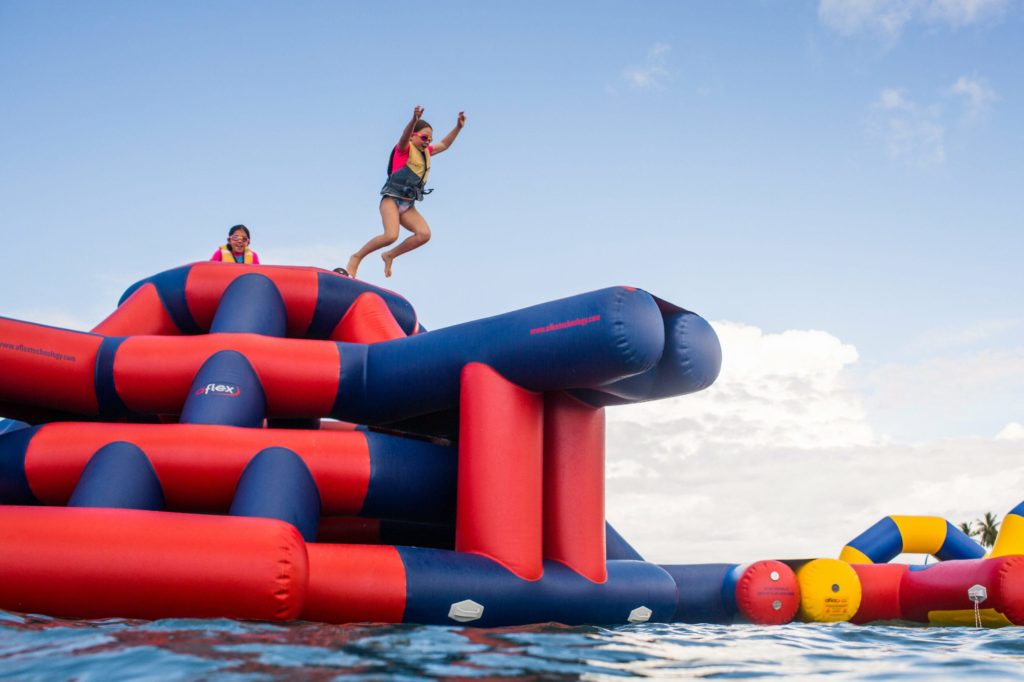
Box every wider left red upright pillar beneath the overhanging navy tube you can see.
[456,363,544,581]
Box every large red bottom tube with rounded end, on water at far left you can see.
[0,507,309,621]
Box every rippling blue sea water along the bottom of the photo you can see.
[0,611,1024,682]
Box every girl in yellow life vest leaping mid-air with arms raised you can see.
[345,106,466,278]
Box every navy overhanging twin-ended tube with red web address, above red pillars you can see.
[332,287,721,424]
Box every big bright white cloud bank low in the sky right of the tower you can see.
[607,323,1024,563]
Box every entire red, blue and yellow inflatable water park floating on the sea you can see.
[0,262,1024,627]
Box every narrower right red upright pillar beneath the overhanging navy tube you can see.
[544,392,608,583]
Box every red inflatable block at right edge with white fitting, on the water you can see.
[899,554,1024,626]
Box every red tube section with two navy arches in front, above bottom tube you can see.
[25,422,370,515]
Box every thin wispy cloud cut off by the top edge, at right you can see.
[818,0,1008,42]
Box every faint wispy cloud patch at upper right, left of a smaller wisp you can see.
[868,88,946,168]
